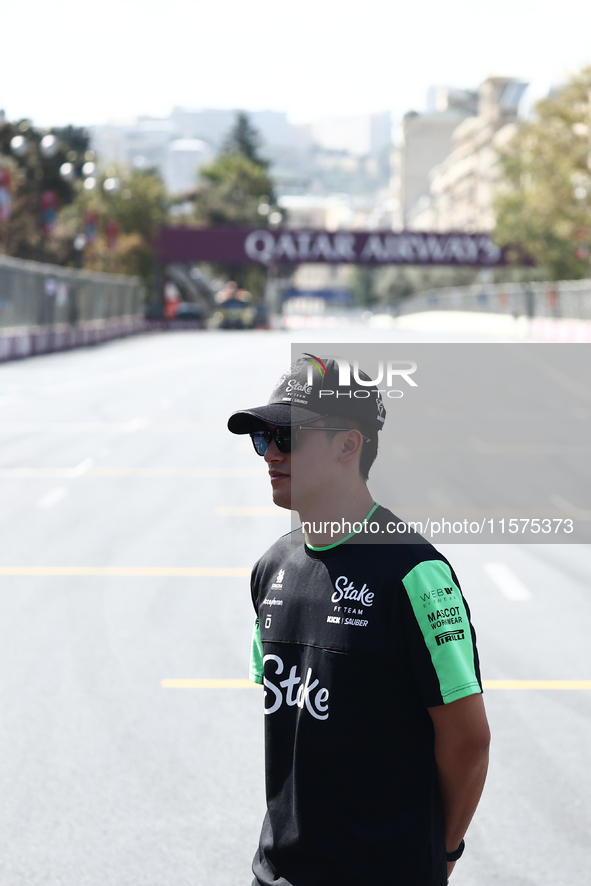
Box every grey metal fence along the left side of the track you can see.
[0,256,146,362]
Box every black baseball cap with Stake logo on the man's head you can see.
[228,354,386,434]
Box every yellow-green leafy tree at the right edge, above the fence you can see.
[495,67,591,280]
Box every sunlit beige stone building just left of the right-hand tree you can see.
[407,77,527,231]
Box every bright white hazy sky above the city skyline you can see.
[0,0,591,126]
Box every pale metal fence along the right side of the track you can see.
[398,280,591,320]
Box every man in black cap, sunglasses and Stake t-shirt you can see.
[228,360,489,886]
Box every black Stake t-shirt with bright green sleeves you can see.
[250,507,482,886]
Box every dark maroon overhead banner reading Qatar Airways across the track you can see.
[157,227,511,268]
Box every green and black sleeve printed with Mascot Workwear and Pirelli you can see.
[403,560,482,704]
